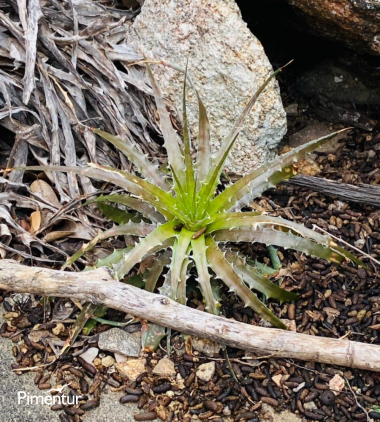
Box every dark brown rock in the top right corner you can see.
[286,0,380,55]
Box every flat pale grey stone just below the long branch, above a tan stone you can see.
[98,328,141,357]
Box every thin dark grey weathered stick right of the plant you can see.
[287,175,380,207]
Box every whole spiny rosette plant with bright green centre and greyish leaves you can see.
[23,65,360,328]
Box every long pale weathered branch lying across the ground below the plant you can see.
[0,260,380,372]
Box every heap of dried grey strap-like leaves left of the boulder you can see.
[0,0,163,262]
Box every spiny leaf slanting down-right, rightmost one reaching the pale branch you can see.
[206,236,287,329]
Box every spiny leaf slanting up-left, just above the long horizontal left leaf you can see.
[92,129,170,191]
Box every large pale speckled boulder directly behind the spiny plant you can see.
[128,0,286,173]
